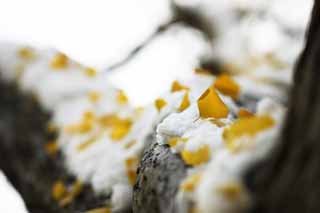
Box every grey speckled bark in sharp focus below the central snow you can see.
[133,141,187,213]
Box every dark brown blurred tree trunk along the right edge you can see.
[247,0,320,213]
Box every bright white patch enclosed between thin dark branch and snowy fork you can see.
[110,25,210,106]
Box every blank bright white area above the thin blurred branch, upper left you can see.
[0,0,171,67]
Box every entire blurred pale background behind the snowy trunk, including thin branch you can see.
[0,0,312,212]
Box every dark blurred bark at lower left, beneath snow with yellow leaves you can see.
[0,81,107,213]
